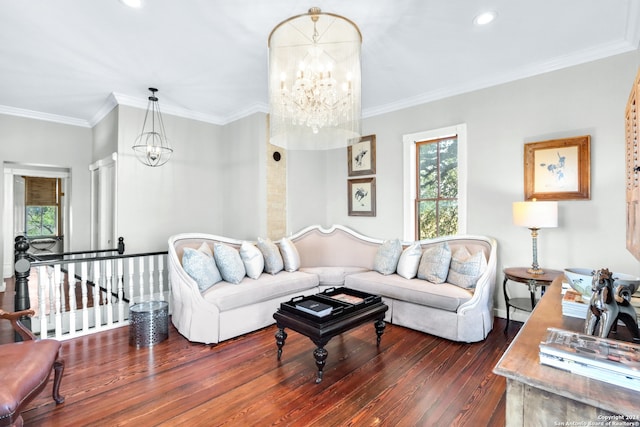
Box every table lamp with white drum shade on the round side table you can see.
[513,199,558,274]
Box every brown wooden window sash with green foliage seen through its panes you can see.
[416,137,458,239]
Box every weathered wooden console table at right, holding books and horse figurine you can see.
[493,275,640,426]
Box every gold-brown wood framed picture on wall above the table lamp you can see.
[524,135,591,200]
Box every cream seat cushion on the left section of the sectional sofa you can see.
[203,271,318,311]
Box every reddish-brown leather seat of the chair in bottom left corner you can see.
[0,339,61,425]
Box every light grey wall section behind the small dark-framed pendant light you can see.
[117,106,225,253]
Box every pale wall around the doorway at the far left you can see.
[0,114,91,277]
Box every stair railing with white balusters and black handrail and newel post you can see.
[15,236,169,339]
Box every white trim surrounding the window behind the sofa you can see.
[402,123,467,241]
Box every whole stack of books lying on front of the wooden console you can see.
[540,328,640,391]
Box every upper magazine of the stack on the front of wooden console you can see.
[540,328,640,380]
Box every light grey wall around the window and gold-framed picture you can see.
[289,52,640,318]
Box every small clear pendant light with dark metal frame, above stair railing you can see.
[131,87,173,167]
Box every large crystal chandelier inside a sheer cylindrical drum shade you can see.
[269,7,362,150]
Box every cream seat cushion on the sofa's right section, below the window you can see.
[344,271,473,312]
